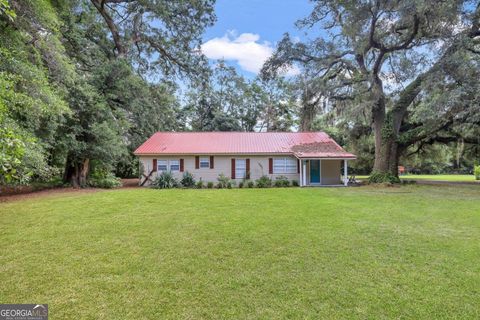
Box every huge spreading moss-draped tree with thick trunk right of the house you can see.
[262,0,480,180]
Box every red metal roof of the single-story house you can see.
[134,132,355,159]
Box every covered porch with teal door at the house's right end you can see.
[299,158,348,187]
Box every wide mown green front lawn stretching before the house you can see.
[0,185,480,319]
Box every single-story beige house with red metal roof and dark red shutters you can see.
[135,132,355,186]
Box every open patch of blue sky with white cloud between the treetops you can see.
[202,0,313,77]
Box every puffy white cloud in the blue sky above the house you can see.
[202,31,298,75]
